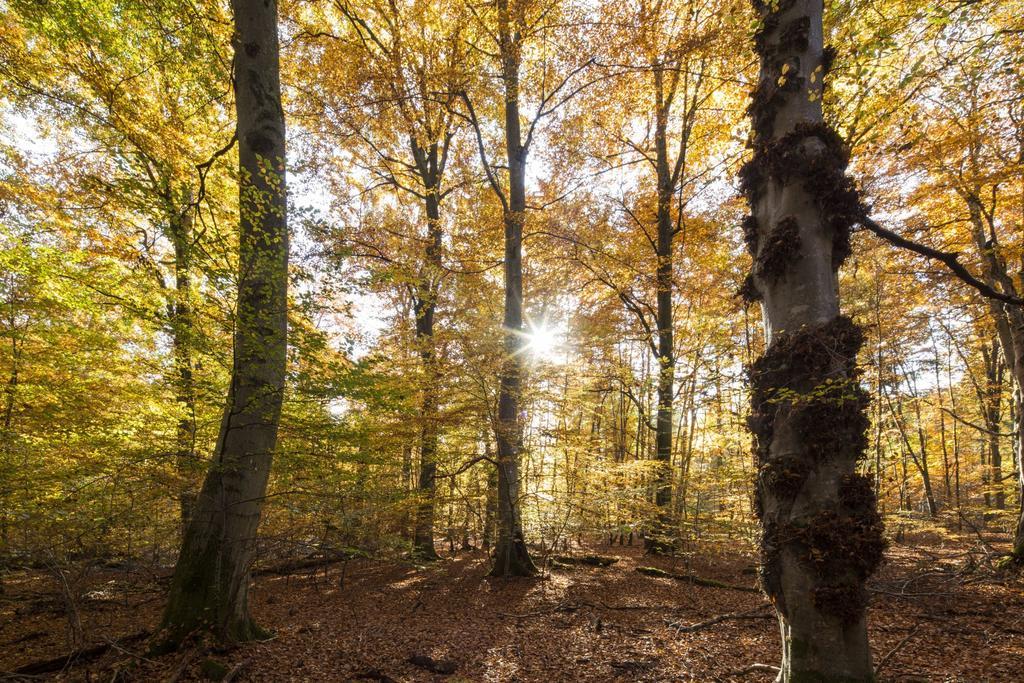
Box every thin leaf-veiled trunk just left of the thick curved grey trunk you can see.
[167,200,198,533]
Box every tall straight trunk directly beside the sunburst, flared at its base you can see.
[490,0,537,577]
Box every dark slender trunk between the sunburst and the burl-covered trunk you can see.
[646,67,677,552]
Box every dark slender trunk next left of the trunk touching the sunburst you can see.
[411,138,442,559]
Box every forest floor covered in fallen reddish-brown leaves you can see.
[0,542,1024,683]
